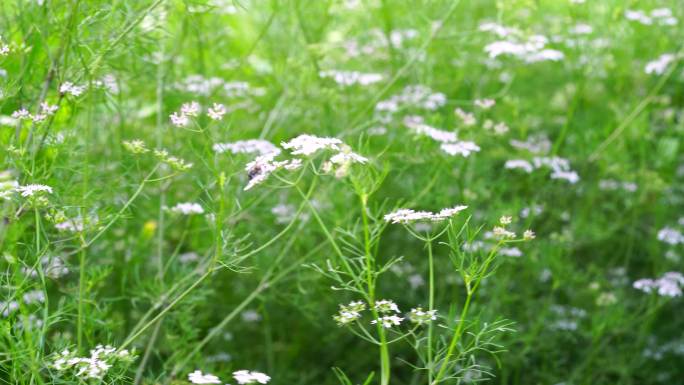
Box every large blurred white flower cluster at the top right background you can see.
[480,23,565,63]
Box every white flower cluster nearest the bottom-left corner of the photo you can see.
[52,345,134,380]
